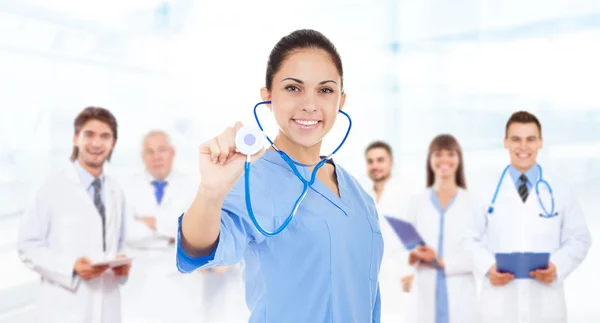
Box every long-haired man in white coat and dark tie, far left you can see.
[18,107,131,323]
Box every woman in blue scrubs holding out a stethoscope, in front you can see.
[177,30,383,323]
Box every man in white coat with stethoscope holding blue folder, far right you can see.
[466,111,591,323]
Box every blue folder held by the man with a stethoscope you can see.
[496,252,550,279]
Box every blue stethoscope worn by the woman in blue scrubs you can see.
[244,101,352,236]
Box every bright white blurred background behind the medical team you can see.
[0,0,600,323]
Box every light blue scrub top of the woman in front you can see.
[177,150,383,323]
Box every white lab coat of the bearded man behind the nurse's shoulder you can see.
[369,179,413,323]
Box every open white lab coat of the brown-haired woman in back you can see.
[405,189,481,323]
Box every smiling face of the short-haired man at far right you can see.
[504,122,542,173]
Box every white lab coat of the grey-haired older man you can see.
[123,171,209,323]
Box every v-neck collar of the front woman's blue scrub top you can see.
[262,149,349,215]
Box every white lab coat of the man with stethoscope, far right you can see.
[466,172,591,323]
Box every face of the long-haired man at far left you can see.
[73,119,116,170]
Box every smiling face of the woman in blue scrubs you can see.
[261,49,346,148]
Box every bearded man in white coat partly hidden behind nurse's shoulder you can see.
[365,141,414,323]
